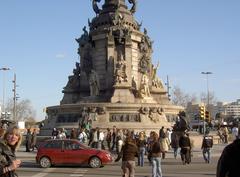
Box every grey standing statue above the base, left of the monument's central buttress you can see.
[89,69,100,96]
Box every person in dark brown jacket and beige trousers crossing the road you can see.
[115,134,138,177]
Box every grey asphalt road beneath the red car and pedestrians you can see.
[17,145,224,177]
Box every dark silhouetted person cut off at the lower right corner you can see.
[217,129,240,177]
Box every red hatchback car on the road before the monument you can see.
[36,139,112,168]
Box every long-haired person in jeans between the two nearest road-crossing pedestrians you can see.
[137,132,147,167]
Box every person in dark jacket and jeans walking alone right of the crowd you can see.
[202,132,213,163]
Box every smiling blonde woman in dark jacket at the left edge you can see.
[0,126,22,177]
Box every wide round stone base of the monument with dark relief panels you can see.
[40,103,181,135]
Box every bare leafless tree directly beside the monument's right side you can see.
[172,86,197,108]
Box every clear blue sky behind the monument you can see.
[0,0,240,120]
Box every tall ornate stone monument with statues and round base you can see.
[42,0,182,134]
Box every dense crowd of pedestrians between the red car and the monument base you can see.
[48,126,211,177]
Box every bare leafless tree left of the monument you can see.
[6,99,36,122]
